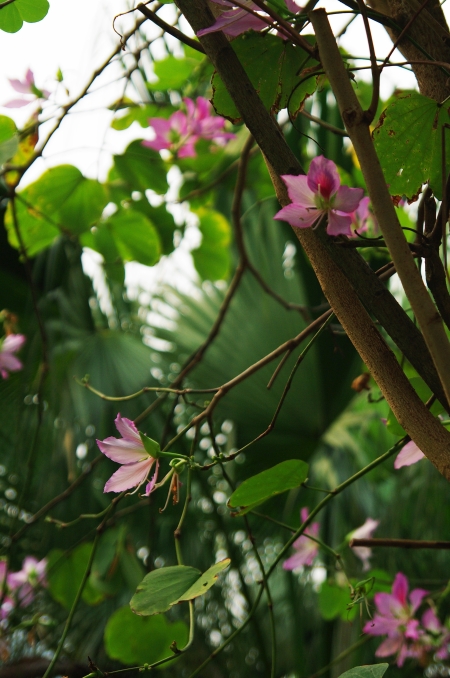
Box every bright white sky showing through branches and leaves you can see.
[0,0,432,298]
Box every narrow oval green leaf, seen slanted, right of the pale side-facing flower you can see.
[228,459,308,515]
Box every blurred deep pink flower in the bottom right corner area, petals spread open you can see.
[364,572,428,666]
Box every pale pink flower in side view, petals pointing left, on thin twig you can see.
[97,414,159,496]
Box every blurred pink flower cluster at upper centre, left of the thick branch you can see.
[142,97,236,158]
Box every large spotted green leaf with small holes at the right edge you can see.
[373,92,450,199]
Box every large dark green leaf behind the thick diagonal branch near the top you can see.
[212,33,317,123]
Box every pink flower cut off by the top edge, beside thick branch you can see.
[197,0,300,38]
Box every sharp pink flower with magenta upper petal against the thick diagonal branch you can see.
[274,155,364,236]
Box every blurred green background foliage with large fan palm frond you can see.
[0,14,450,678]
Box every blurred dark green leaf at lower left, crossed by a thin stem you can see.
[48,543,104,610]
